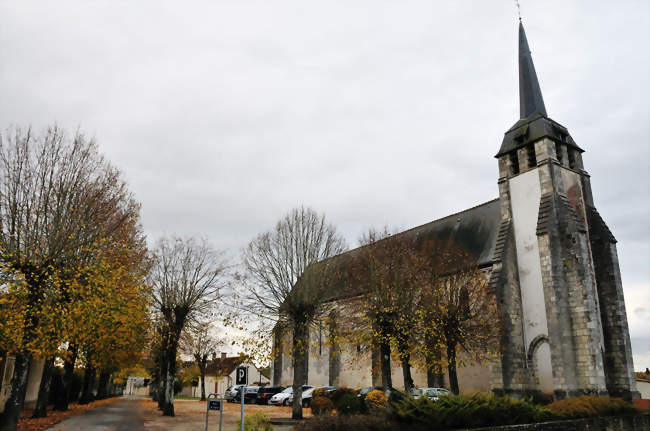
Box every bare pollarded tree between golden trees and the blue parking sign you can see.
[150,238,226,416]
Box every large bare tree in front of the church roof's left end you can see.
[243,207,346,418]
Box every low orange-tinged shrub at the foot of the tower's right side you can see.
[547,396,639,419]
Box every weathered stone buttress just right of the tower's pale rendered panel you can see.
[537,140,606,397]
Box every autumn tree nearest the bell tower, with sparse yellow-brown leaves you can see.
[416,240,500,394]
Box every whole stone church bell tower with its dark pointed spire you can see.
[493,23,636,399]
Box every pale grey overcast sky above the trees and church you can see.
[0,0,650,370]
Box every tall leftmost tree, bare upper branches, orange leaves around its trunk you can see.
[0,127,142,431]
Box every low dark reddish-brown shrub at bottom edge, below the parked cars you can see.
[294,415,399,431]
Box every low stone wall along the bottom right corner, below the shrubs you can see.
[466,413,650,431]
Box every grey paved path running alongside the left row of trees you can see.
[47,397,144,431]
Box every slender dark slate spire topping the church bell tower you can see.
[519,20,546,119]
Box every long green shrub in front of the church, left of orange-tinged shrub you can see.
[392,394,554,429]
